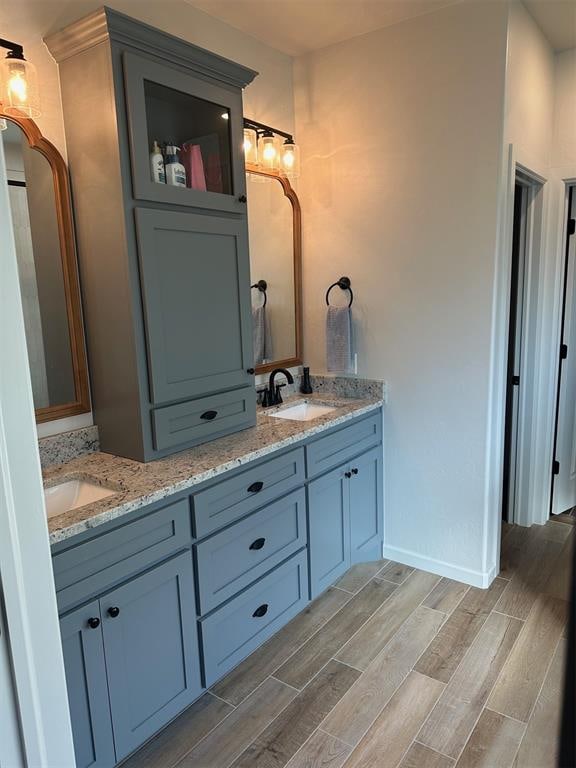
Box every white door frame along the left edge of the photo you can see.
[0,130,75,768]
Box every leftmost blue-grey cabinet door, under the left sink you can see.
[60,601,116,768]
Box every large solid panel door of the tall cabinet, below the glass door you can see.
[136,208,253,405]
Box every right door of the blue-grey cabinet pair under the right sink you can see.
[349,446,383,563]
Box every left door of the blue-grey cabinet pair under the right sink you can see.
[308,467,350,599]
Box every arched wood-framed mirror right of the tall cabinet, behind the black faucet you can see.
[246,164,302,373]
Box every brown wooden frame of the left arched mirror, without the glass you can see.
[0,109,91,424]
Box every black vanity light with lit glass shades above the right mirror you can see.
[244,117,300,179]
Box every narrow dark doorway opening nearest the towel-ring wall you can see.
[502,183,530,523]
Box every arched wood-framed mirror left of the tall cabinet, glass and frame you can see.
[0,110,90,422]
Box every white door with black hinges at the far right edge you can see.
[550,186,576,516]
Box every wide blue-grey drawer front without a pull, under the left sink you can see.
[52,498,192,611]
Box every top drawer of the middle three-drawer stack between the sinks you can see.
[194,448,305,538]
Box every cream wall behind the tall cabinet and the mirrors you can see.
[0,0,294,436]
